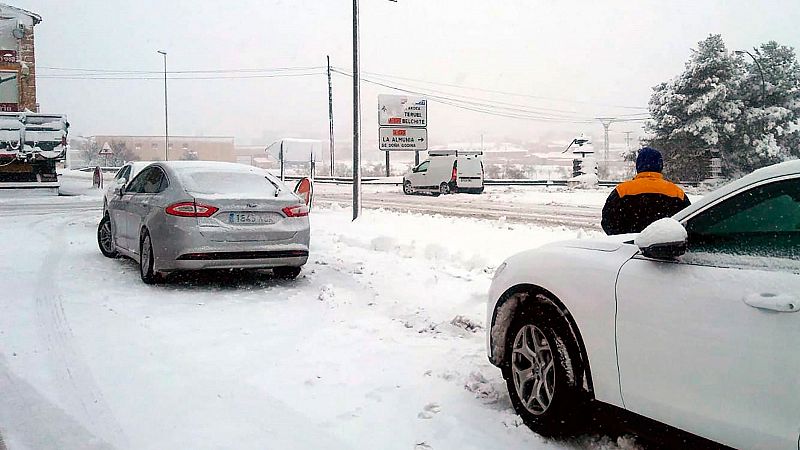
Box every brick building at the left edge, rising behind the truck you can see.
[0,3,42,112]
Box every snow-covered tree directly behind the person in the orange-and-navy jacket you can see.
[646,35,743,180]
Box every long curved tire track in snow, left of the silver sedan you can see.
[35,213,127,448]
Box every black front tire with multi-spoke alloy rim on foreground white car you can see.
[502,296,589,437]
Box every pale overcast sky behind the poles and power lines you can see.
[10,0,800,153]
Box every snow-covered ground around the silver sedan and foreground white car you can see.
[0,174,644,449]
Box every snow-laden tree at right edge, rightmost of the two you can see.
[727,41,800,172]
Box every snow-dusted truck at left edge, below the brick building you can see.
[0,112,69,193]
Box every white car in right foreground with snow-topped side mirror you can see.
[487,161,800,449]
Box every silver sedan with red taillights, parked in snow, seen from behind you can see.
[97,161,310,284]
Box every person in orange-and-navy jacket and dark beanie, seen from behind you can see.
[602,147,690,235]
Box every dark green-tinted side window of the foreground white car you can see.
[686,179,800,258]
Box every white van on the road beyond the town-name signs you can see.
[403,150,483,195]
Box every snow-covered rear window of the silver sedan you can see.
[181,171,275,195]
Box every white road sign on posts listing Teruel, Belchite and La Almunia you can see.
[378,95,428,177]
